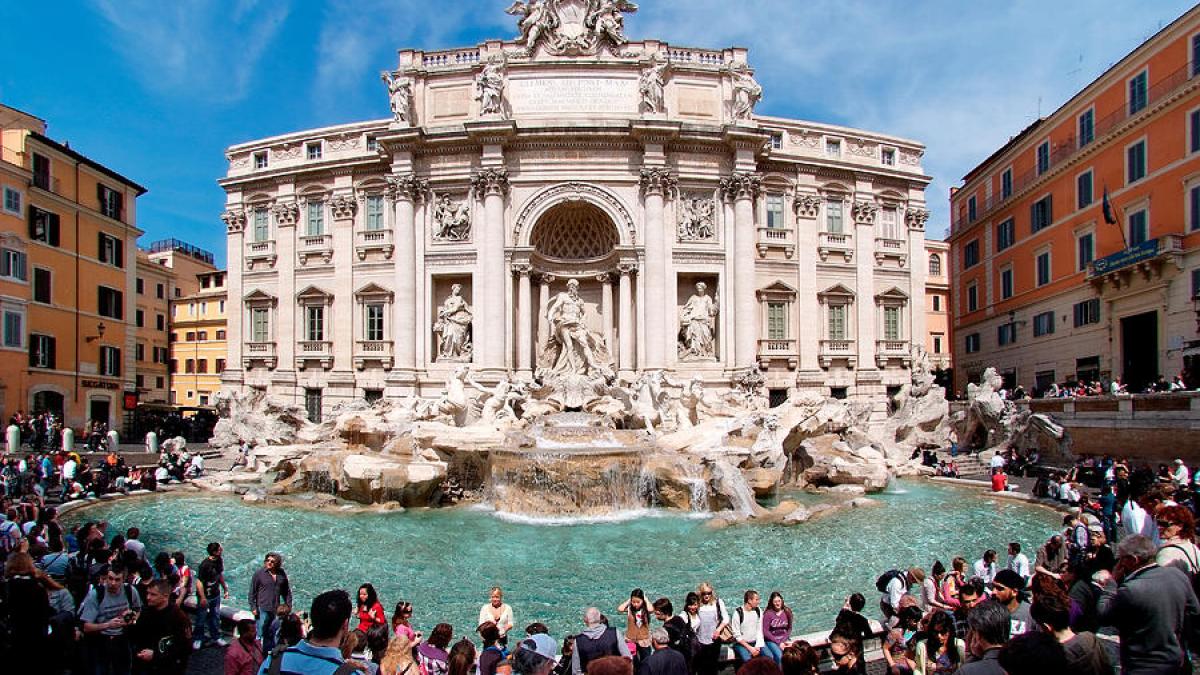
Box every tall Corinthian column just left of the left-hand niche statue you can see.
[388,173,428,375]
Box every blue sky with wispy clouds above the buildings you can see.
[0,0,1192,261]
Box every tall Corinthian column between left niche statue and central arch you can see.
[470,168,509,371]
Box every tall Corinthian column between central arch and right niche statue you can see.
[642,168,677,369]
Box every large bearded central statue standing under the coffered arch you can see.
[542,279,612,378]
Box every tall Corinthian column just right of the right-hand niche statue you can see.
[721,172,762,369]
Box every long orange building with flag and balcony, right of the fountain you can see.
[949,8,1200,390]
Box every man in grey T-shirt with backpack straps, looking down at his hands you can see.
[79,562,142,675]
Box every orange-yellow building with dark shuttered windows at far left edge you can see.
[0,100,145,429]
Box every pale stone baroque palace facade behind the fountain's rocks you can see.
[220,0,929,417]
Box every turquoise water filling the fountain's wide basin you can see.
[68,482,1061,637]
